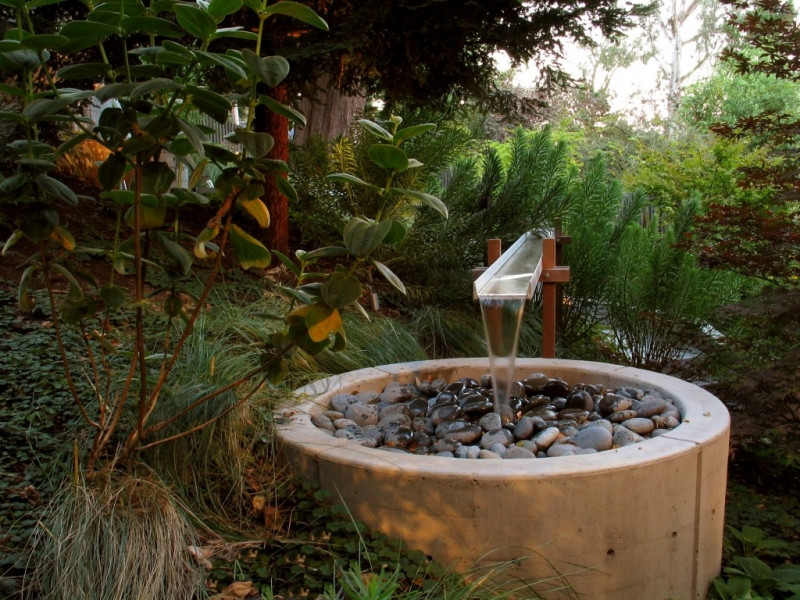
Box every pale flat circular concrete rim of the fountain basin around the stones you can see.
[276,358,730,481]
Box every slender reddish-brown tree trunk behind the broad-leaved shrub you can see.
[254,85,289,254]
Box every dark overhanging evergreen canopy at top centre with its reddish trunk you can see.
[247,0,646,250]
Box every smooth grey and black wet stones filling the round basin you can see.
[311,373,681,458]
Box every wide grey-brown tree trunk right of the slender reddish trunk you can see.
[292,74,366,146]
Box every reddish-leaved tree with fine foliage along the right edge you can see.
[680,0,800,287]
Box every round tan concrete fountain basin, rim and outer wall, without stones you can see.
[276,358,730,600]
